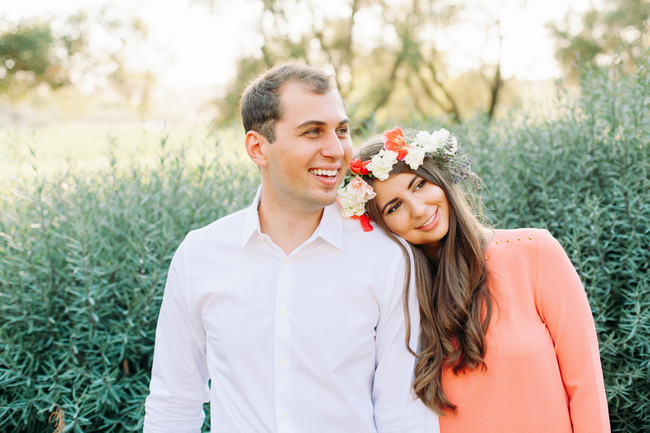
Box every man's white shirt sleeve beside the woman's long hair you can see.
[372,241,440,433]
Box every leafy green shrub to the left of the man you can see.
[0,138,258,432]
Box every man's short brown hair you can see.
[241,63,332,143]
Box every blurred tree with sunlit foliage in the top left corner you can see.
[0,7,155,114]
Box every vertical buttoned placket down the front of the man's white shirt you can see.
[273,257,294,433]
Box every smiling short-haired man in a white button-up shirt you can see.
[144,65,438,433]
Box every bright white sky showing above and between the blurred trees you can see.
[0,0,591,89]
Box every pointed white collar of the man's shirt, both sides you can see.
[242,185,343,250]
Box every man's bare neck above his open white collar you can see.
[258,192,323,254]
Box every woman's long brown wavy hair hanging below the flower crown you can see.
[359,137,493,413]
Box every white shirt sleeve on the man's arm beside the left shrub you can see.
[143,239,209,433]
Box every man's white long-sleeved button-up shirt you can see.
[144,192,438,433]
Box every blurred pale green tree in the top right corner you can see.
[548,0,650,80]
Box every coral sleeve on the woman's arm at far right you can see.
[536,231,610,433]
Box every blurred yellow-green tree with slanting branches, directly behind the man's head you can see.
[195,0,504,127]
